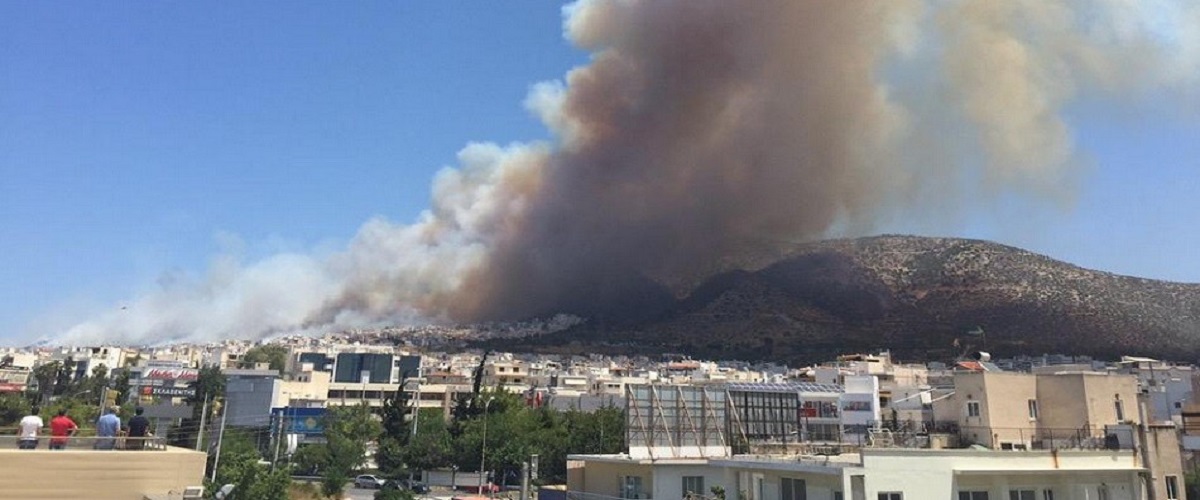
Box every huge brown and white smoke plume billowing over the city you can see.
[65,0,1200,342]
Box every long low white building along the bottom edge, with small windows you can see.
[568,448,1184,500]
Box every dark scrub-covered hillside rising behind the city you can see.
[484,236,1200,362]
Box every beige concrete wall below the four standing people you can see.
[0,444,205,500]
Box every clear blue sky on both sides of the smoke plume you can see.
[0,1,1200,341]
